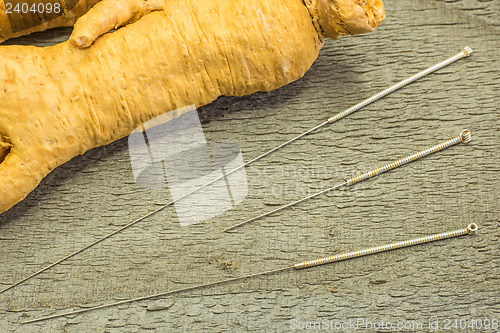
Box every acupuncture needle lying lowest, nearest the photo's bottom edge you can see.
[21,223,478,324]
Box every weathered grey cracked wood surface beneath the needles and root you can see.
[0,0,500,332]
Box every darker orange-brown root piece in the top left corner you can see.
[0,0,100,43]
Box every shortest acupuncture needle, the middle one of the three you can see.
[223,130,472,232]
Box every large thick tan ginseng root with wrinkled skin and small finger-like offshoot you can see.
[0,0,383,212]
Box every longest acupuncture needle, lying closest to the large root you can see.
[0,46,473,294]
